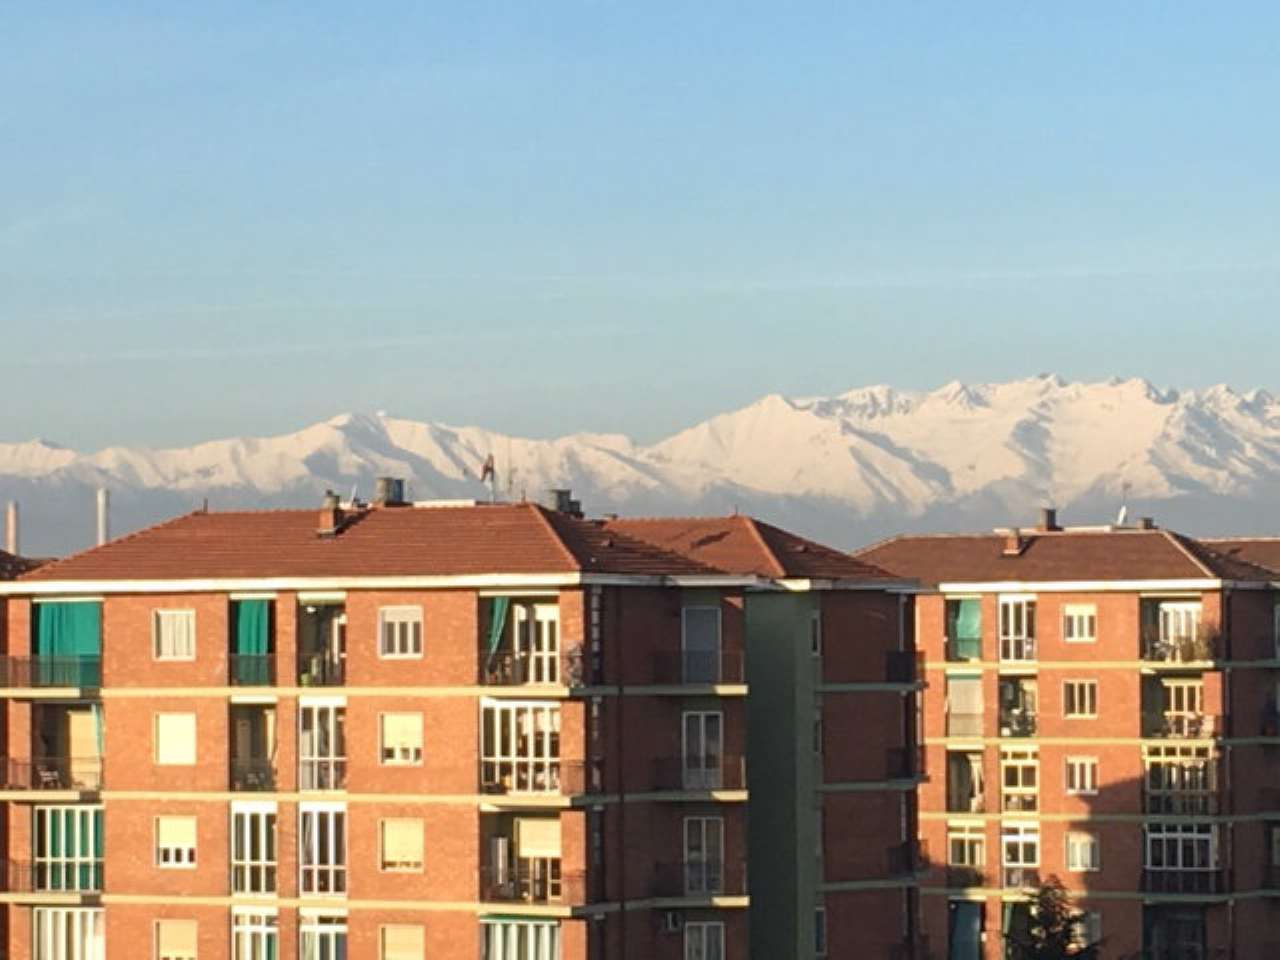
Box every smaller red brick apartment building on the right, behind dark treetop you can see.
[858,511,1280,960]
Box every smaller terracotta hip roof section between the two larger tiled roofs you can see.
[604,516,897,580]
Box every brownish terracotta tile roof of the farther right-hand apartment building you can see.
[856,529,1244,584]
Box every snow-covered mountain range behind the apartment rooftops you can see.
[0,375,1280,554]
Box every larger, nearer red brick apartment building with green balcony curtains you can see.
[0,485,919,960]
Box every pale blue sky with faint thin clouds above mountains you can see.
[0,0,1280,449]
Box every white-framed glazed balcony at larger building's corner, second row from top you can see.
[480,700,561,794]
